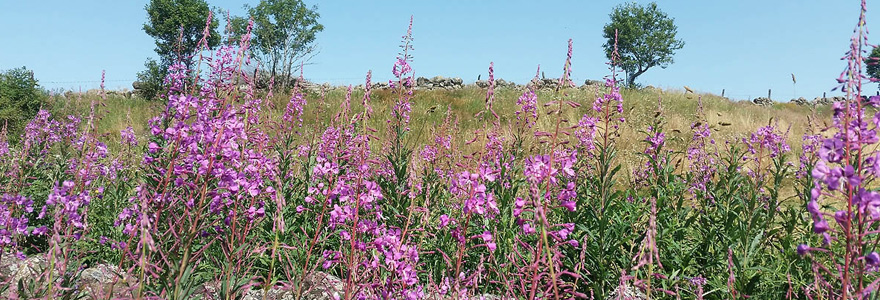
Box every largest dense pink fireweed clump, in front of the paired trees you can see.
[116,32,275,264]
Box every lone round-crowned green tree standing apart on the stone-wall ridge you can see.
[603,2,684,86]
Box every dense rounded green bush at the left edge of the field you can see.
[0,67,45,142]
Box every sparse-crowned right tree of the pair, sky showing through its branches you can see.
[231,0,324,87]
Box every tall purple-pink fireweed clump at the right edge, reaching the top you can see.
[797,1,880,299]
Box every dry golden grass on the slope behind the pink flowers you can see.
[50,84,830,174]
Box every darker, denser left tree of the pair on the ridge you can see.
[144,0,220,69]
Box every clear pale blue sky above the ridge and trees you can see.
[0,0,880,100]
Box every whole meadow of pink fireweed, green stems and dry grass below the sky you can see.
[0,0,880,300]
